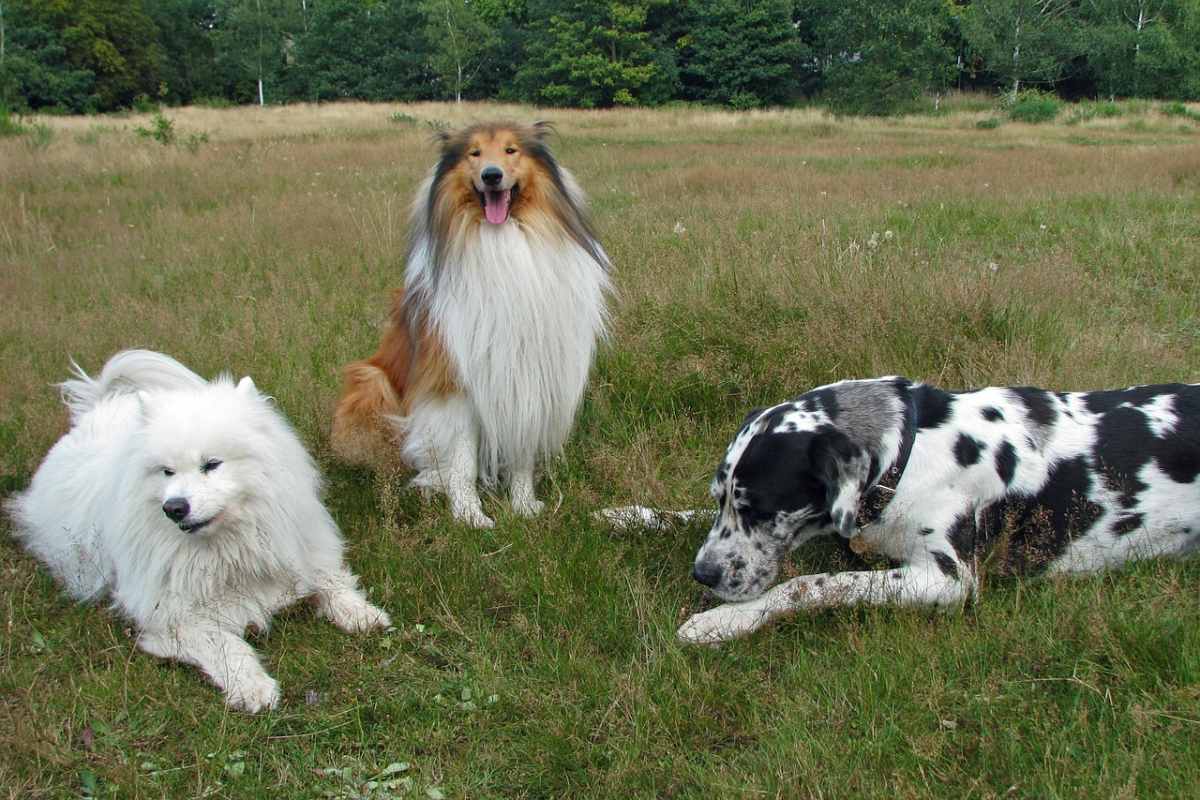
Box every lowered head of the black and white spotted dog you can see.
[692,381,902,601]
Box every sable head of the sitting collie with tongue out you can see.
[414,122,608,267]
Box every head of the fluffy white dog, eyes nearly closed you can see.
[138,378,316,536]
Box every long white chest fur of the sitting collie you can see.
[420,219,610,482]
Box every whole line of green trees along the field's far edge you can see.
[0,0,1200,114]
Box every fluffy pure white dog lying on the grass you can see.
[7,350,390,712]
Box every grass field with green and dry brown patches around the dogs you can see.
[7,104,1200,799]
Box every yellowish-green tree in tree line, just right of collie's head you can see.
[516,0,670,108]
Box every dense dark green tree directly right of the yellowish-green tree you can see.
[677,0,808,107]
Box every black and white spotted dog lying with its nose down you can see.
[606,378,1200,642]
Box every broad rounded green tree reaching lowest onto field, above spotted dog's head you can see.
[798,0,955,115]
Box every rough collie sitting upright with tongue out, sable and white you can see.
[332,124,610,528]
